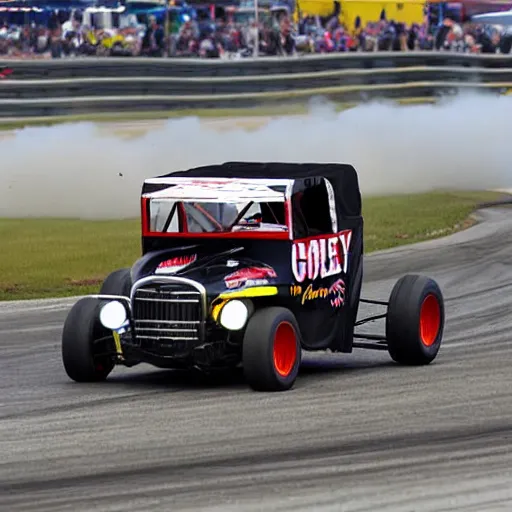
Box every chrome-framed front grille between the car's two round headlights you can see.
[132,283,203,355]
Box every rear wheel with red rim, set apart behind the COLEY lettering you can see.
[386,274,444,365]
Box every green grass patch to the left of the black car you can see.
[0,219,140,300]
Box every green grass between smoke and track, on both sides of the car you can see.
[0,188,503,300]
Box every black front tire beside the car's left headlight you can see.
[62,297,115,382]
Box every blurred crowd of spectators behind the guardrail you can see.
[0,7,512,58]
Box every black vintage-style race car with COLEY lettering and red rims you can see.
[62,162,444,391]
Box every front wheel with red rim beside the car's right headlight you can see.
[242,307,301,391]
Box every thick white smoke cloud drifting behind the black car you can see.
[0,95,512,218]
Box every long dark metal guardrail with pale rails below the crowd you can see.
[0,52,512,117]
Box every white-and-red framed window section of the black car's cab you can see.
[141,177,338,240]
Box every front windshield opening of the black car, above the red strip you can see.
[149,199,288,233]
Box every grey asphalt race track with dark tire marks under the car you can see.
[0,206,512,512]
